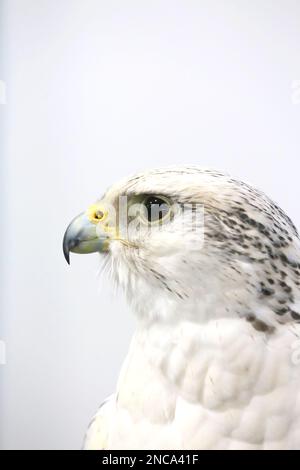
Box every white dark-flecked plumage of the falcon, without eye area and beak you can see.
[63,167,300,449]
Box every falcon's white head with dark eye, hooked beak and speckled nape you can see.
[63,166,299,323]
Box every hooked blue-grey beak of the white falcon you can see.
[63,212,110,264]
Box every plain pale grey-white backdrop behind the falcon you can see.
[0,0,300,449]
